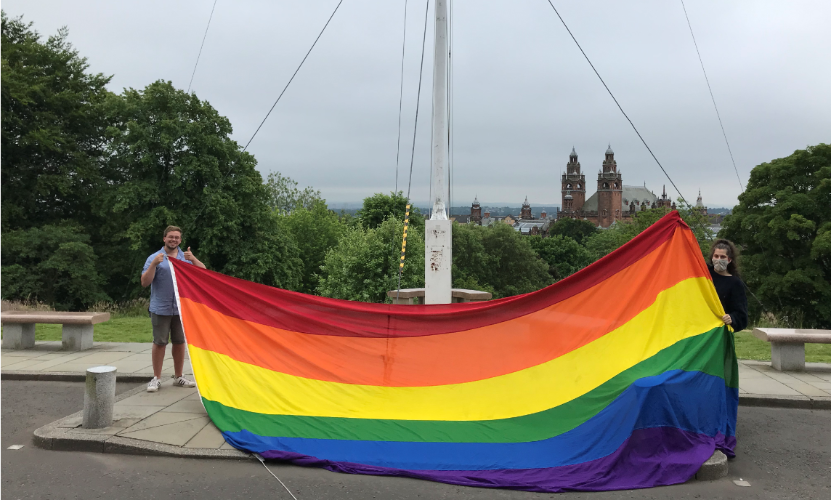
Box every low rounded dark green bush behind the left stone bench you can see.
[2,225,108,311]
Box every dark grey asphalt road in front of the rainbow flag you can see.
[0,381,831,500]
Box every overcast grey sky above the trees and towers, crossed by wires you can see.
[2,0,831,207]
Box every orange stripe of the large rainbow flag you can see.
[181,231,709,387]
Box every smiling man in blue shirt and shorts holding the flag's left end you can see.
[141,226,205,392]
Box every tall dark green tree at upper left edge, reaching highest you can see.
[0,12,111,231]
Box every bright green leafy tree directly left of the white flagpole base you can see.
[318,217,424,303]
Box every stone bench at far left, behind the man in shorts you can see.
[0,311,110,351]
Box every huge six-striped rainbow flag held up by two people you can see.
[172,212,738,492]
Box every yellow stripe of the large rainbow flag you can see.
[190,278,723,421]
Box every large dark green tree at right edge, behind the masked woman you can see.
[719,144,831,328]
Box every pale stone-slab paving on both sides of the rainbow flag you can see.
[0,342,831,457]
